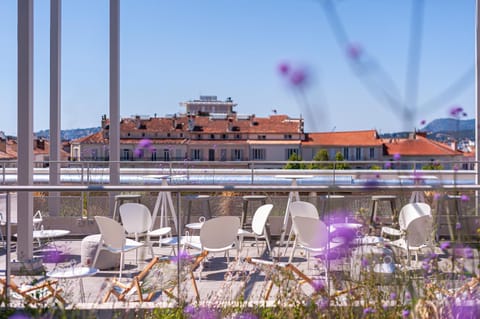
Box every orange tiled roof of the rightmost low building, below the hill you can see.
[384,135,462,156]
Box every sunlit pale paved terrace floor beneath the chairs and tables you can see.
[0,234,478,308]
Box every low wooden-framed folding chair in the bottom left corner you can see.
[0,277,65,306]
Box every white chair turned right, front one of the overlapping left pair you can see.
[93,216,143,278]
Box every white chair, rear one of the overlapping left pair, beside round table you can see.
[119,203,172,258]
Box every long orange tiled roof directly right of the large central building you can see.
[303,130,382,146]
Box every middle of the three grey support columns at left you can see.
[48,0,62,216]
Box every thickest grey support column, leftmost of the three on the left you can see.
[17,0,33,261]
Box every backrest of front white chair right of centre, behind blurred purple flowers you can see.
[293,216,328,248]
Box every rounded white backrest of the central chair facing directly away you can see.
[200,216,240,249]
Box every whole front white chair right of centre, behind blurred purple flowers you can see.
[288,216,343,272]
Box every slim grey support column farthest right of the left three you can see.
[108,0,120,216]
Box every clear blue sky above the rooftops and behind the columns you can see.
[0,0,476,135]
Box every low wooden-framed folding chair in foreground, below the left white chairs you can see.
[102,257,200,302]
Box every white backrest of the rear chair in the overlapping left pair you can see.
[119,203,152,234]
